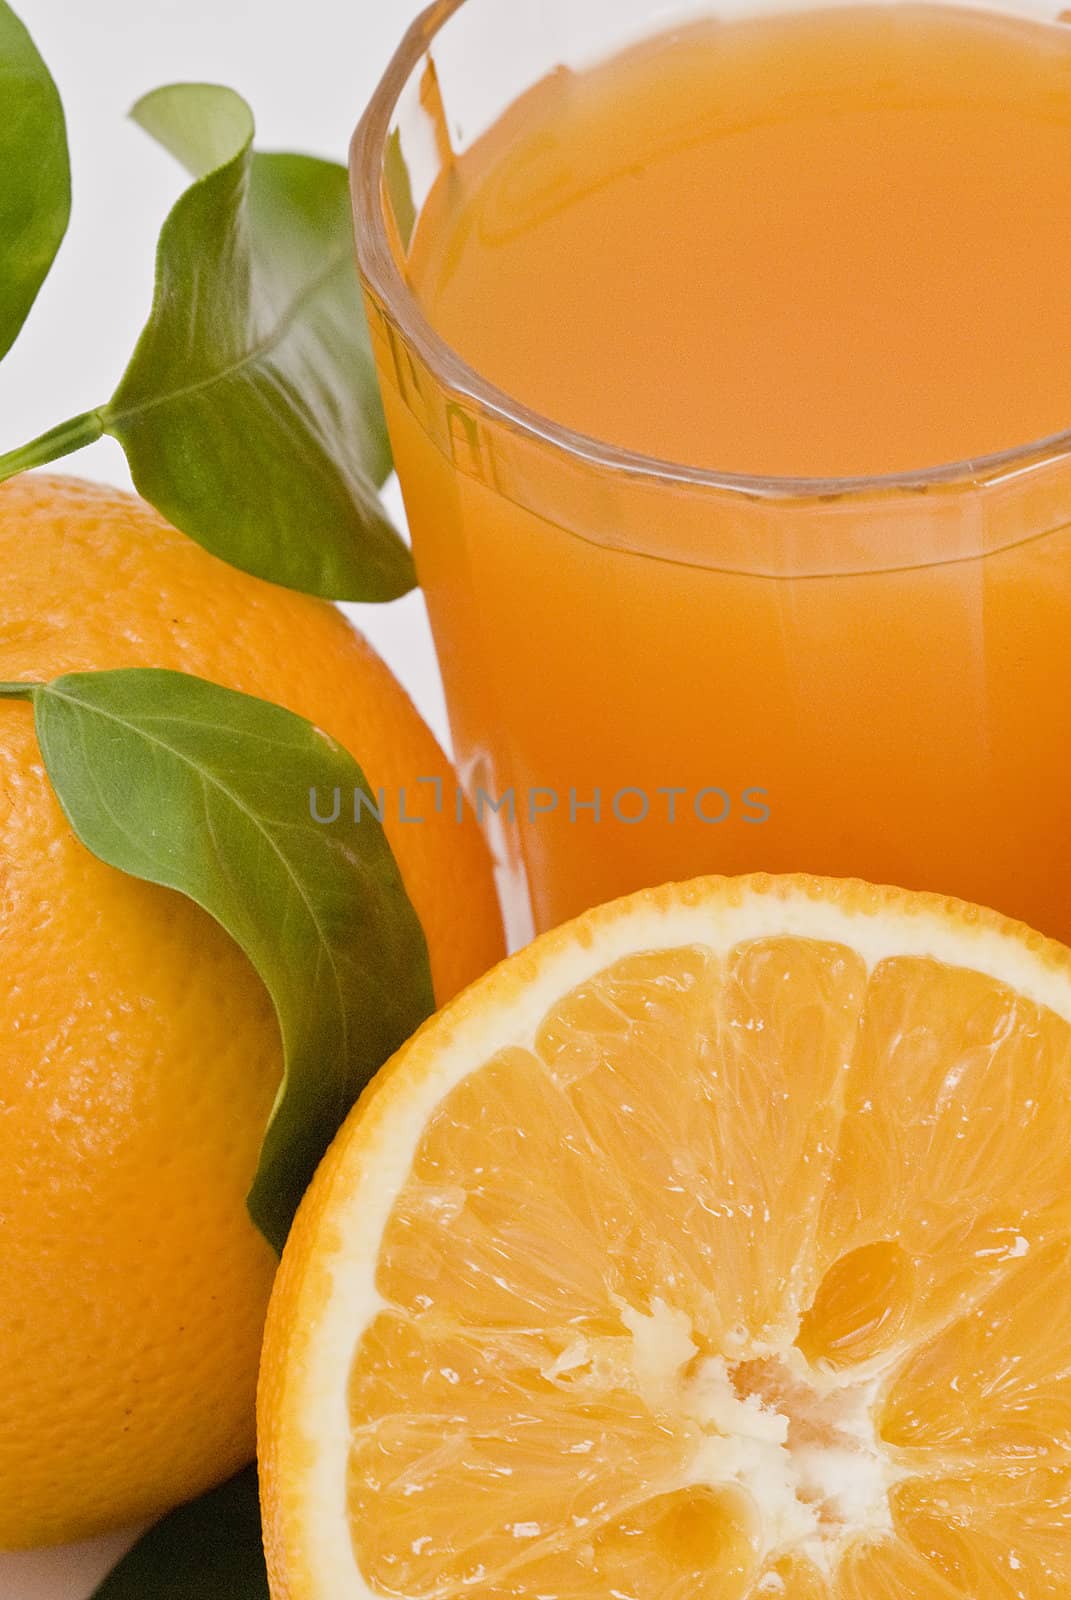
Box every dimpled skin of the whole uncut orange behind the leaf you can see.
[0,477,503,1549]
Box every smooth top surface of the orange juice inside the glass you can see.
[410,5,1071,477]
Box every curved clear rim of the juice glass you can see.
[349,0,1071,501]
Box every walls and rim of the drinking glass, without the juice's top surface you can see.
[352,0,1071,941]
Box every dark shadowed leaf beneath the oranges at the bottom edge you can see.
[93,1467,267,1600]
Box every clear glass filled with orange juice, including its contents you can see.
[352,0,1071,939]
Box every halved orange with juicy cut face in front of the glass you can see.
[259,878,1071,1600]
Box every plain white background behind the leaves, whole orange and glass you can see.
[0,0,445,1600]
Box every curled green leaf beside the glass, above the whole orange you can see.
[99,83,406,600]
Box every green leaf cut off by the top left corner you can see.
[0,0,70,357]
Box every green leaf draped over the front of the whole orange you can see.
[27,669,434,1250]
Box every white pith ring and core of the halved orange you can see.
[275,890,1071,1600]
